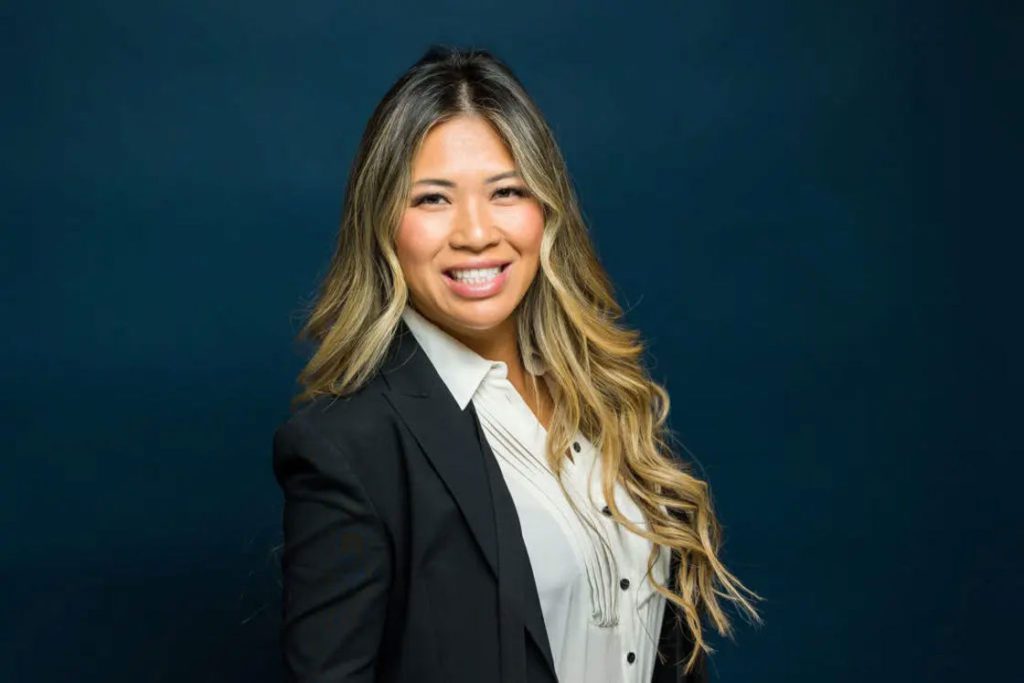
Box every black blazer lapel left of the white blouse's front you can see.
[381,321,557,683]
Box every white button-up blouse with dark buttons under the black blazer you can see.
[402,305,671,683]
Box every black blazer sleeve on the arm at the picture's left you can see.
[272,415,392,683]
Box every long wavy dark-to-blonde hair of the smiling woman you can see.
[293,45,763,673]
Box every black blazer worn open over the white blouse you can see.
[273,321,706,683]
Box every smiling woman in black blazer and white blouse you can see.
[273,48,759,683]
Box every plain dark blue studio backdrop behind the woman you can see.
[0,0,1024,682]
